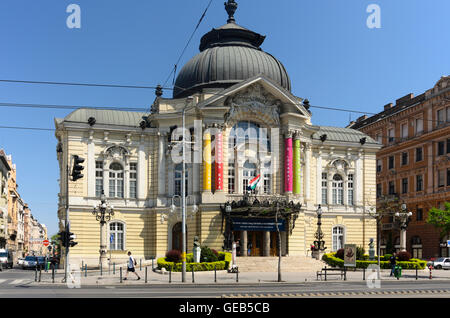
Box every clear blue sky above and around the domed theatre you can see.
[0,0,450,234]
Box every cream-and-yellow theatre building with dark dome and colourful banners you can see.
[55,1,381,263]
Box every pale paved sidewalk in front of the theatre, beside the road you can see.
[31,266,450,287]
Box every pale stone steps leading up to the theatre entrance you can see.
[237,256,326,272]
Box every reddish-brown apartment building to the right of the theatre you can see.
[348,76,450,258]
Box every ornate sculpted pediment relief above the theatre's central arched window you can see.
[225,84,282,125]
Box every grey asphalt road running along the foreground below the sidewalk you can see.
[0,269,450,298]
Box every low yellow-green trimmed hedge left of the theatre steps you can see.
[157,252,231,272]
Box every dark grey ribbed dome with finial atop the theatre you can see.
[173,1,291,98]
